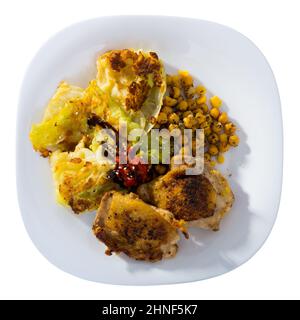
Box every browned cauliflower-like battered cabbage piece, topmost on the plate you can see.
[97,49,166,131]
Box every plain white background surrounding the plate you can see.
[0,0,300,299]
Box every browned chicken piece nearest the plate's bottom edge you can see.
[93,191,182,262]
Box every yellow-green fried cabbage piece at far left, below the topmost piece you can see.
[30,80,143,157]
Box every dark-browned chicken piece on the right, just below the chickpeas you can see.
[137,165,234,230]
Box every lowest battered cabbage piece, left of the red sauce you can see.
[50,141,117,214]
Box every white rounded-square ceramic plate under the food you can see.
[17,16,282,285]
